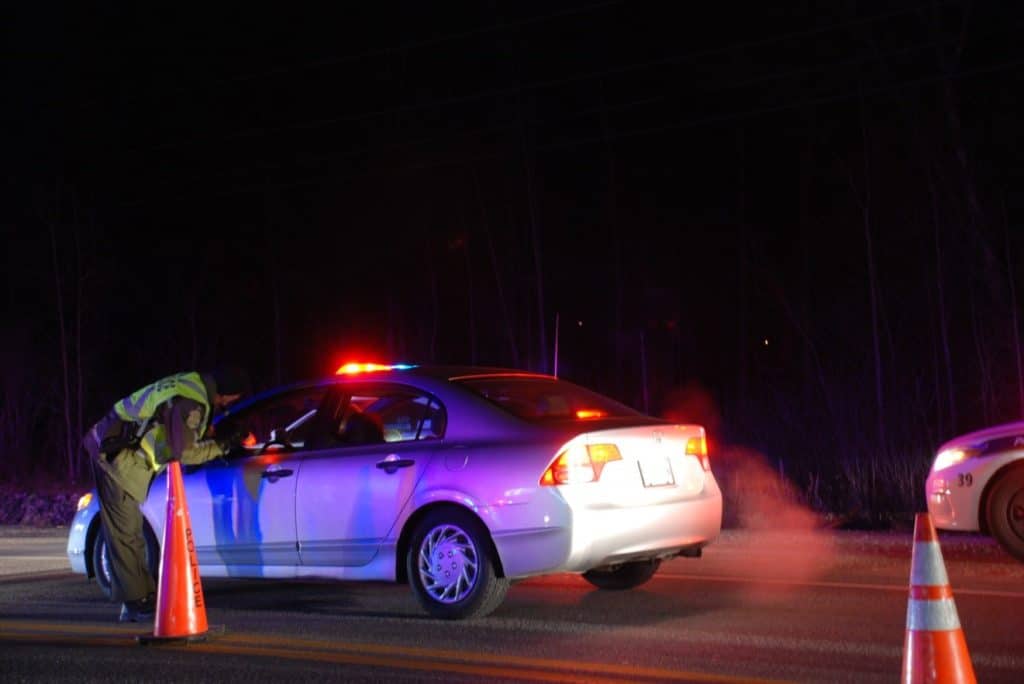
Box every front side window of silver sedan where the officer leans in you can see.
[217,387,328,448]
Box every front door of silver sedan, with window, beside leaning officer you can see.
[183,386,327,576]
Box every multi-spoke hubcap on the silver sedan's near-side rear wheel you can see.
[418,525,479,603]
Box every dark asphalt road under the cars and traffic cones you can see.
[0,529,1024,682]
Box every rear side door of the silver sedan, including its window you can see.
[296,385,443,566]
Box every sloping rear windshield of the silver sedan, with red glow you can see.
[455,376,642,421]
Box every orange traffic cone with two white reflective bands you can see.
[902,513,978,684]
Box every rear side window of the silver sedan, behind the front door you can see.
[323,386,444,445]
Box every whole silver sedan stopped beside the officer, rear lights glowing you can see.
[68,366,722,618]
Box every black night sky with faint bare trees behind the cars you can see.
[0,1,1024,501]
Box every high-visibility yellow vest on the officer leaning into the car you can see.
[114,373,210,472]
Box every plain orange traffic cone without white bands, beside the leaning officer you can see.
[138,461,223,644]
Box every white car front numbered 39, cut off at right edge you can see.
[925,421,1024,560]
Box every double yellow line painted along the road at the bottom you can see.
[0,621,772,684]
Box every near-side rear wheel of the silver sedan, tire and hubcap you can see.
[406,508,509,619]
